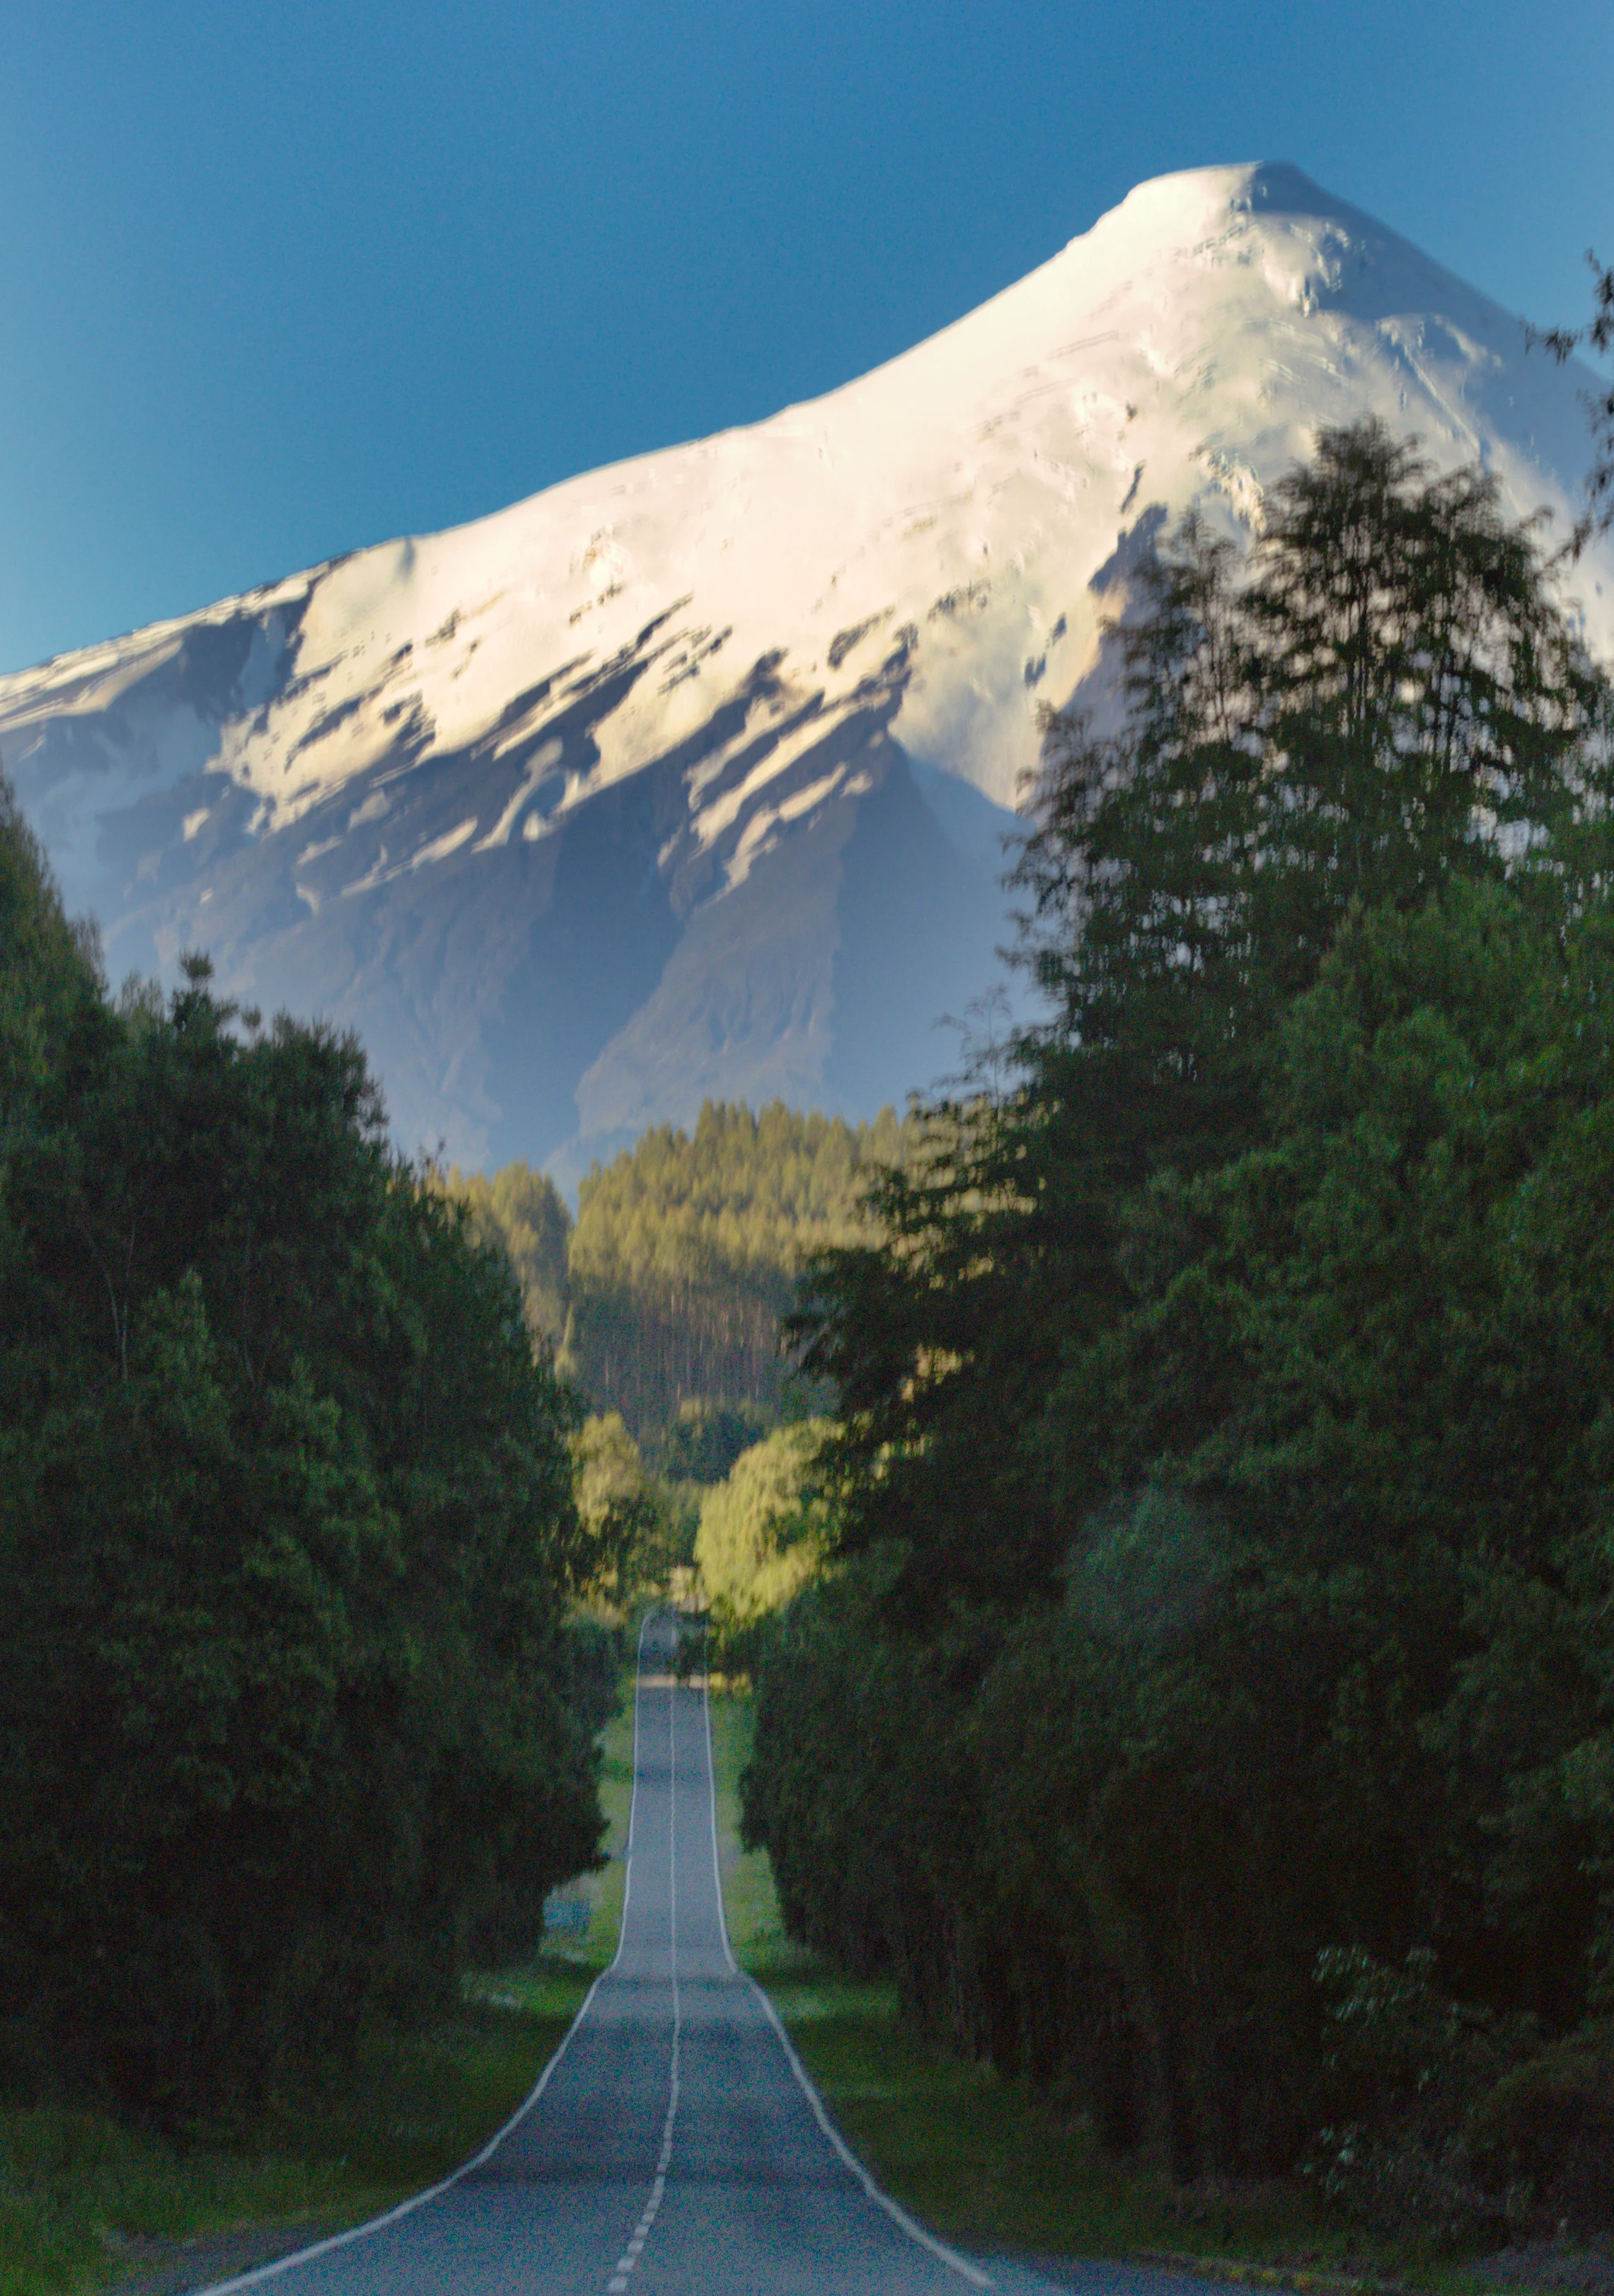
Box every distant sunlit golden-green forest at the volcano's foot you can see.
[454,1102,909,1465]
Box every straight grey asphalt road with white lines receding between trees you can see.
[195,1619,1166,2296]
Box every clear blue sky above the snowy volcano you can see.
[0,0,1614,671]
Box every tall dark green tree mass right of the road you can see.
[747,425,1614,2241]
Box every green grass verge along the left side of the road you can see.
[0,1685,634,2296]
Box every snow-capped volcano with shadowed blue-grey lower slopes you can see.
[0,166,1614,1162]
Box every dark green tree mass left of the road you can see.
[0,783,616,2121]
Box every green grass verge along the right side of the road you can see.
[712,1692,1515,2296]
